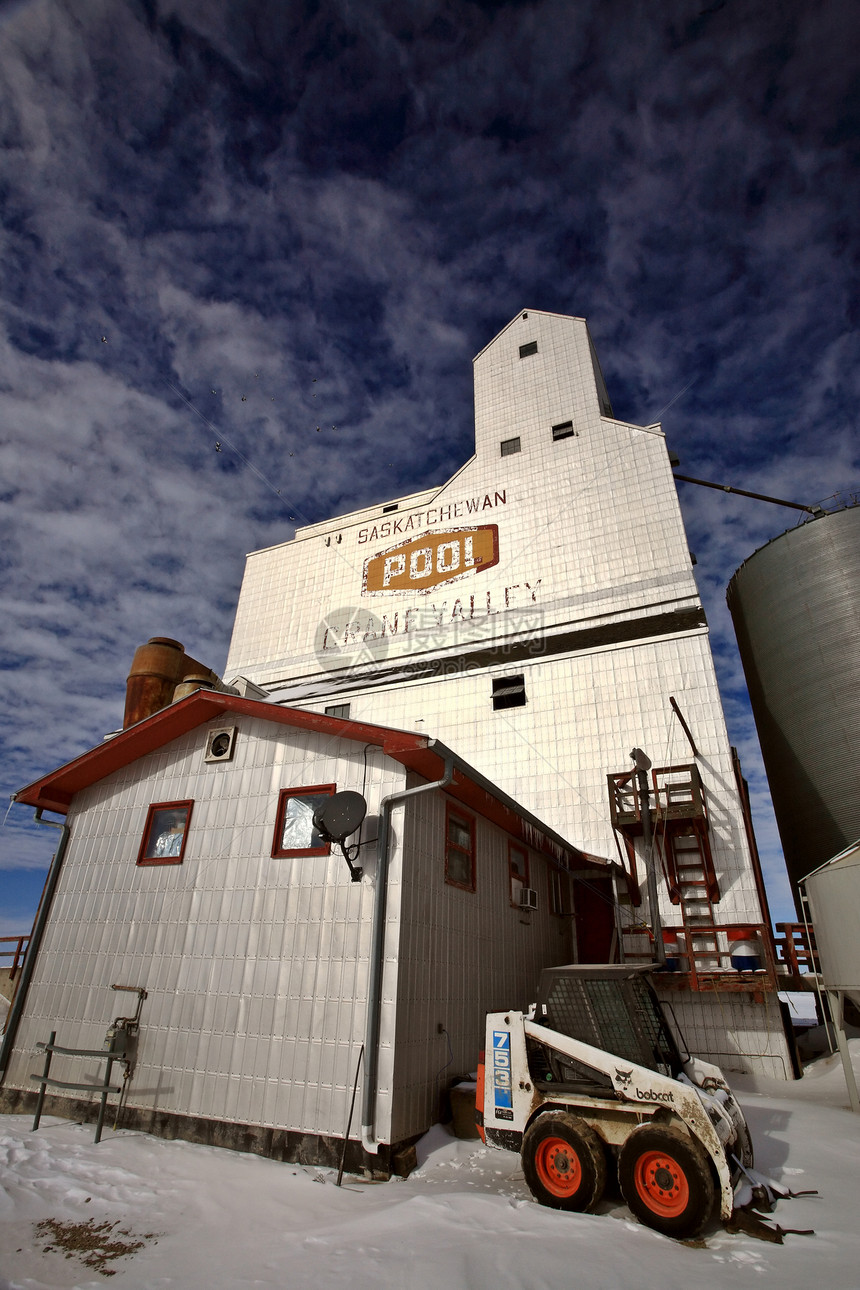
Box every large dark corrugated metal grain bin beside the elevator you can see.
[727,506,860,900]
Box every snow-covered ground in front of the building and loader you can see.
[0,1041,860,1290]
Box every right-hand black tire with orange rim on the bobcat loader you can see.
[618,1125,717,1238]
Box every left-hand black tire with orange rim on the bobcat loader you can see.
[522,1111,606,1214]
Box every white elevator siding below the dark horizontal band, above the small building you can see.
[282,632,761,922]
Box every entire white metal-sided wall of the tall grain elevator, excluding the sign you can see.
[228,311,762,939]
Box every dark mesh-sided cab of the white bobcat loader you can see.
[529,964,683,1091]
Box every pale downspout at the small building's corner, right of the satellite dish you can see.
[361,739,454,1156]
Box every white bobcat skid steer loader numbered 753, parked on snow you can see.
[476,965,753,1237]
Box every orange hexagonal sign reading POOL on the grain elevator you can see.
[362,524,499,596]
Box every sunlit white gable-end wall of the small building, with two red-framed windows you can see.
[8,719,405,1134]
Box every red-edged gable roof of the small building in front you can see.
[13,690,610,875]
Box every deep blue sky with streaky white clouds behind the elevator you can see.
[0,0,860,935]
